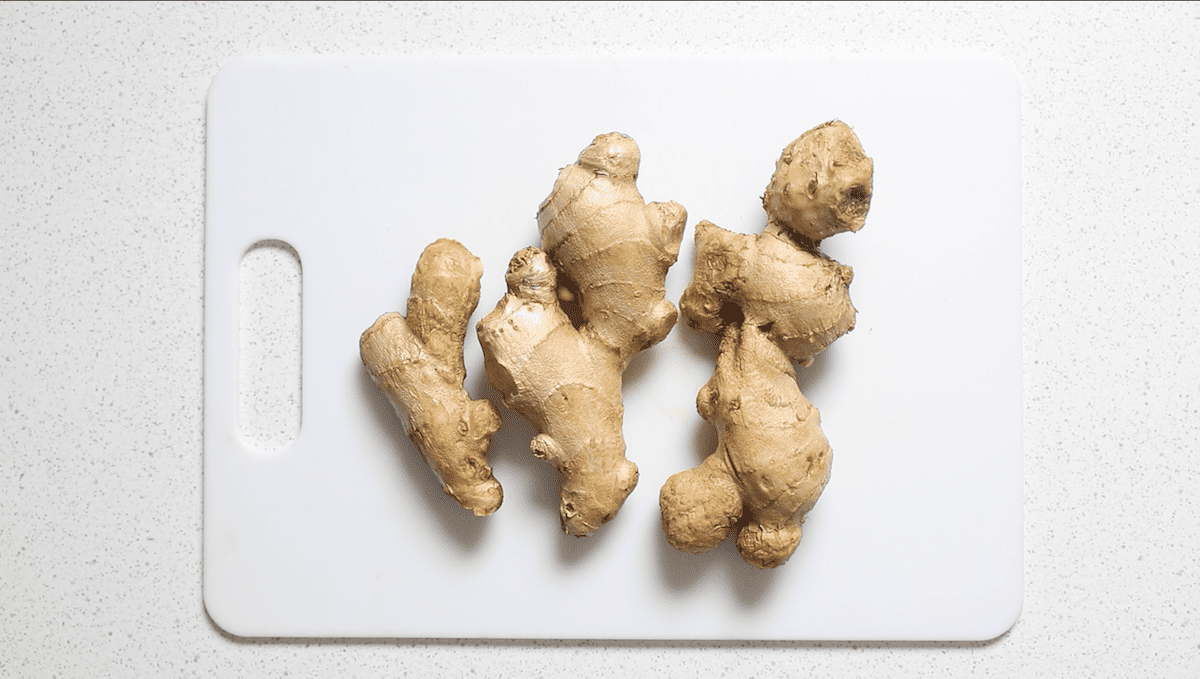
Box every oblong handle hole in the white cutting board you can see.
[238,240,304,452]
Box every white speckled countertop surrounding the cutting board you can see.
[0,2,1200,677]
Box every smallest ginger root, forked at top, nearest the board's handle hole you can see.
[359,239,504,516]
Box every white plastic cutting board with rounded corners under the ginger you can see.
[204,58,1022,639]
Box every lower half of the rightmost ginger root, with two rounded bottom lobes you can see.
[659,323,833,569]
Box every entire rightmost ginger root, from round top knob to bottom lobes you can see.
[659,121,874,569]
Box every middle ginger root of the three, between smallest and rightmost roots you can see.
[476,133,686,536]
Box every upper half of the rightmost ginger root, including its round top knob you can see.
[679,121,874,366]
